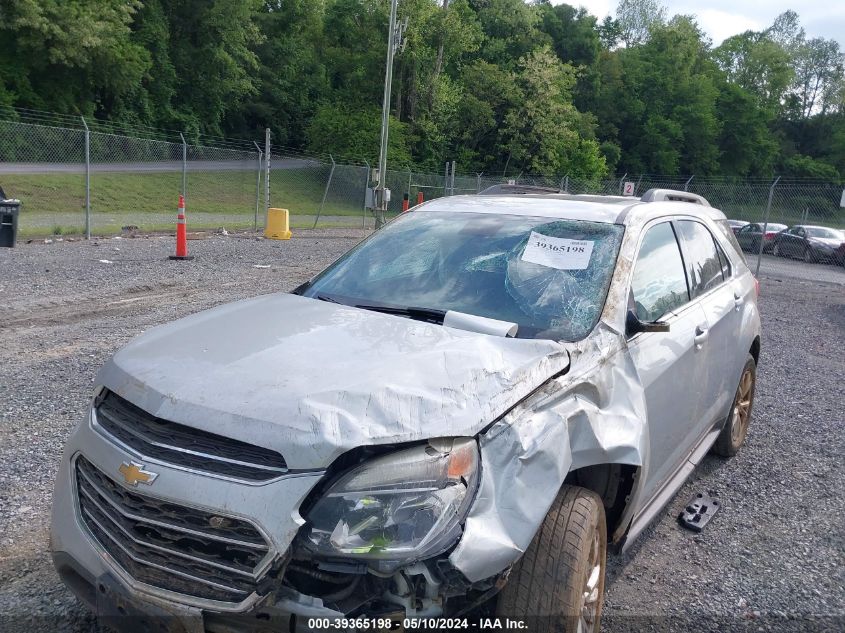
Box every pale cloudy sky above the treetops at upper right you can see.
[553,0,845,50]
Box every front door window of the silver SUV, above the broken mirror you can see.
[631,222,689,321]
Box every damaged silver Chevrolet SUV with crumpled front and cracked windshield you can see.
[51,190,760,632]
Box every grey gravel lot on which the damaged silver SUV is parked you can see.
[0,230,845,631]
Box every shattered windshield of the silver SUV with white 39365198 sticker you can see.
[302,211,623,341]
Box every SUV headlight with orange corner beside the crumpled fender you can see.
[306,438,479,570]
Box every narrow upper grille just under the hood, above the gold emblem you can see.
[97,392,287,481]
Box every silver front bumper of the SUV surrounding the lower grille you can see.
[50,412,337,633]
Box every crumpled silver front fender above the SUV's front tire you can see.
[450,325,648,582]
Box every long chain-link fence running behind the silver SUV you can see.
[0,110,845,282]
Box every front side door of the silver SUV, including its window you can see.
[628,220,708,499]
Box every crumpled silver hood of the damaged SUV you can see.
[97,294,569,469]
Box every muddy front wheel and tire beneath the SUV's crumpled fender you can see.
[496,486,607,633]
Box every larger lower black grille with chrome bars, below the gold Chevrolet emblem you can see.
[76,456,269,602]
